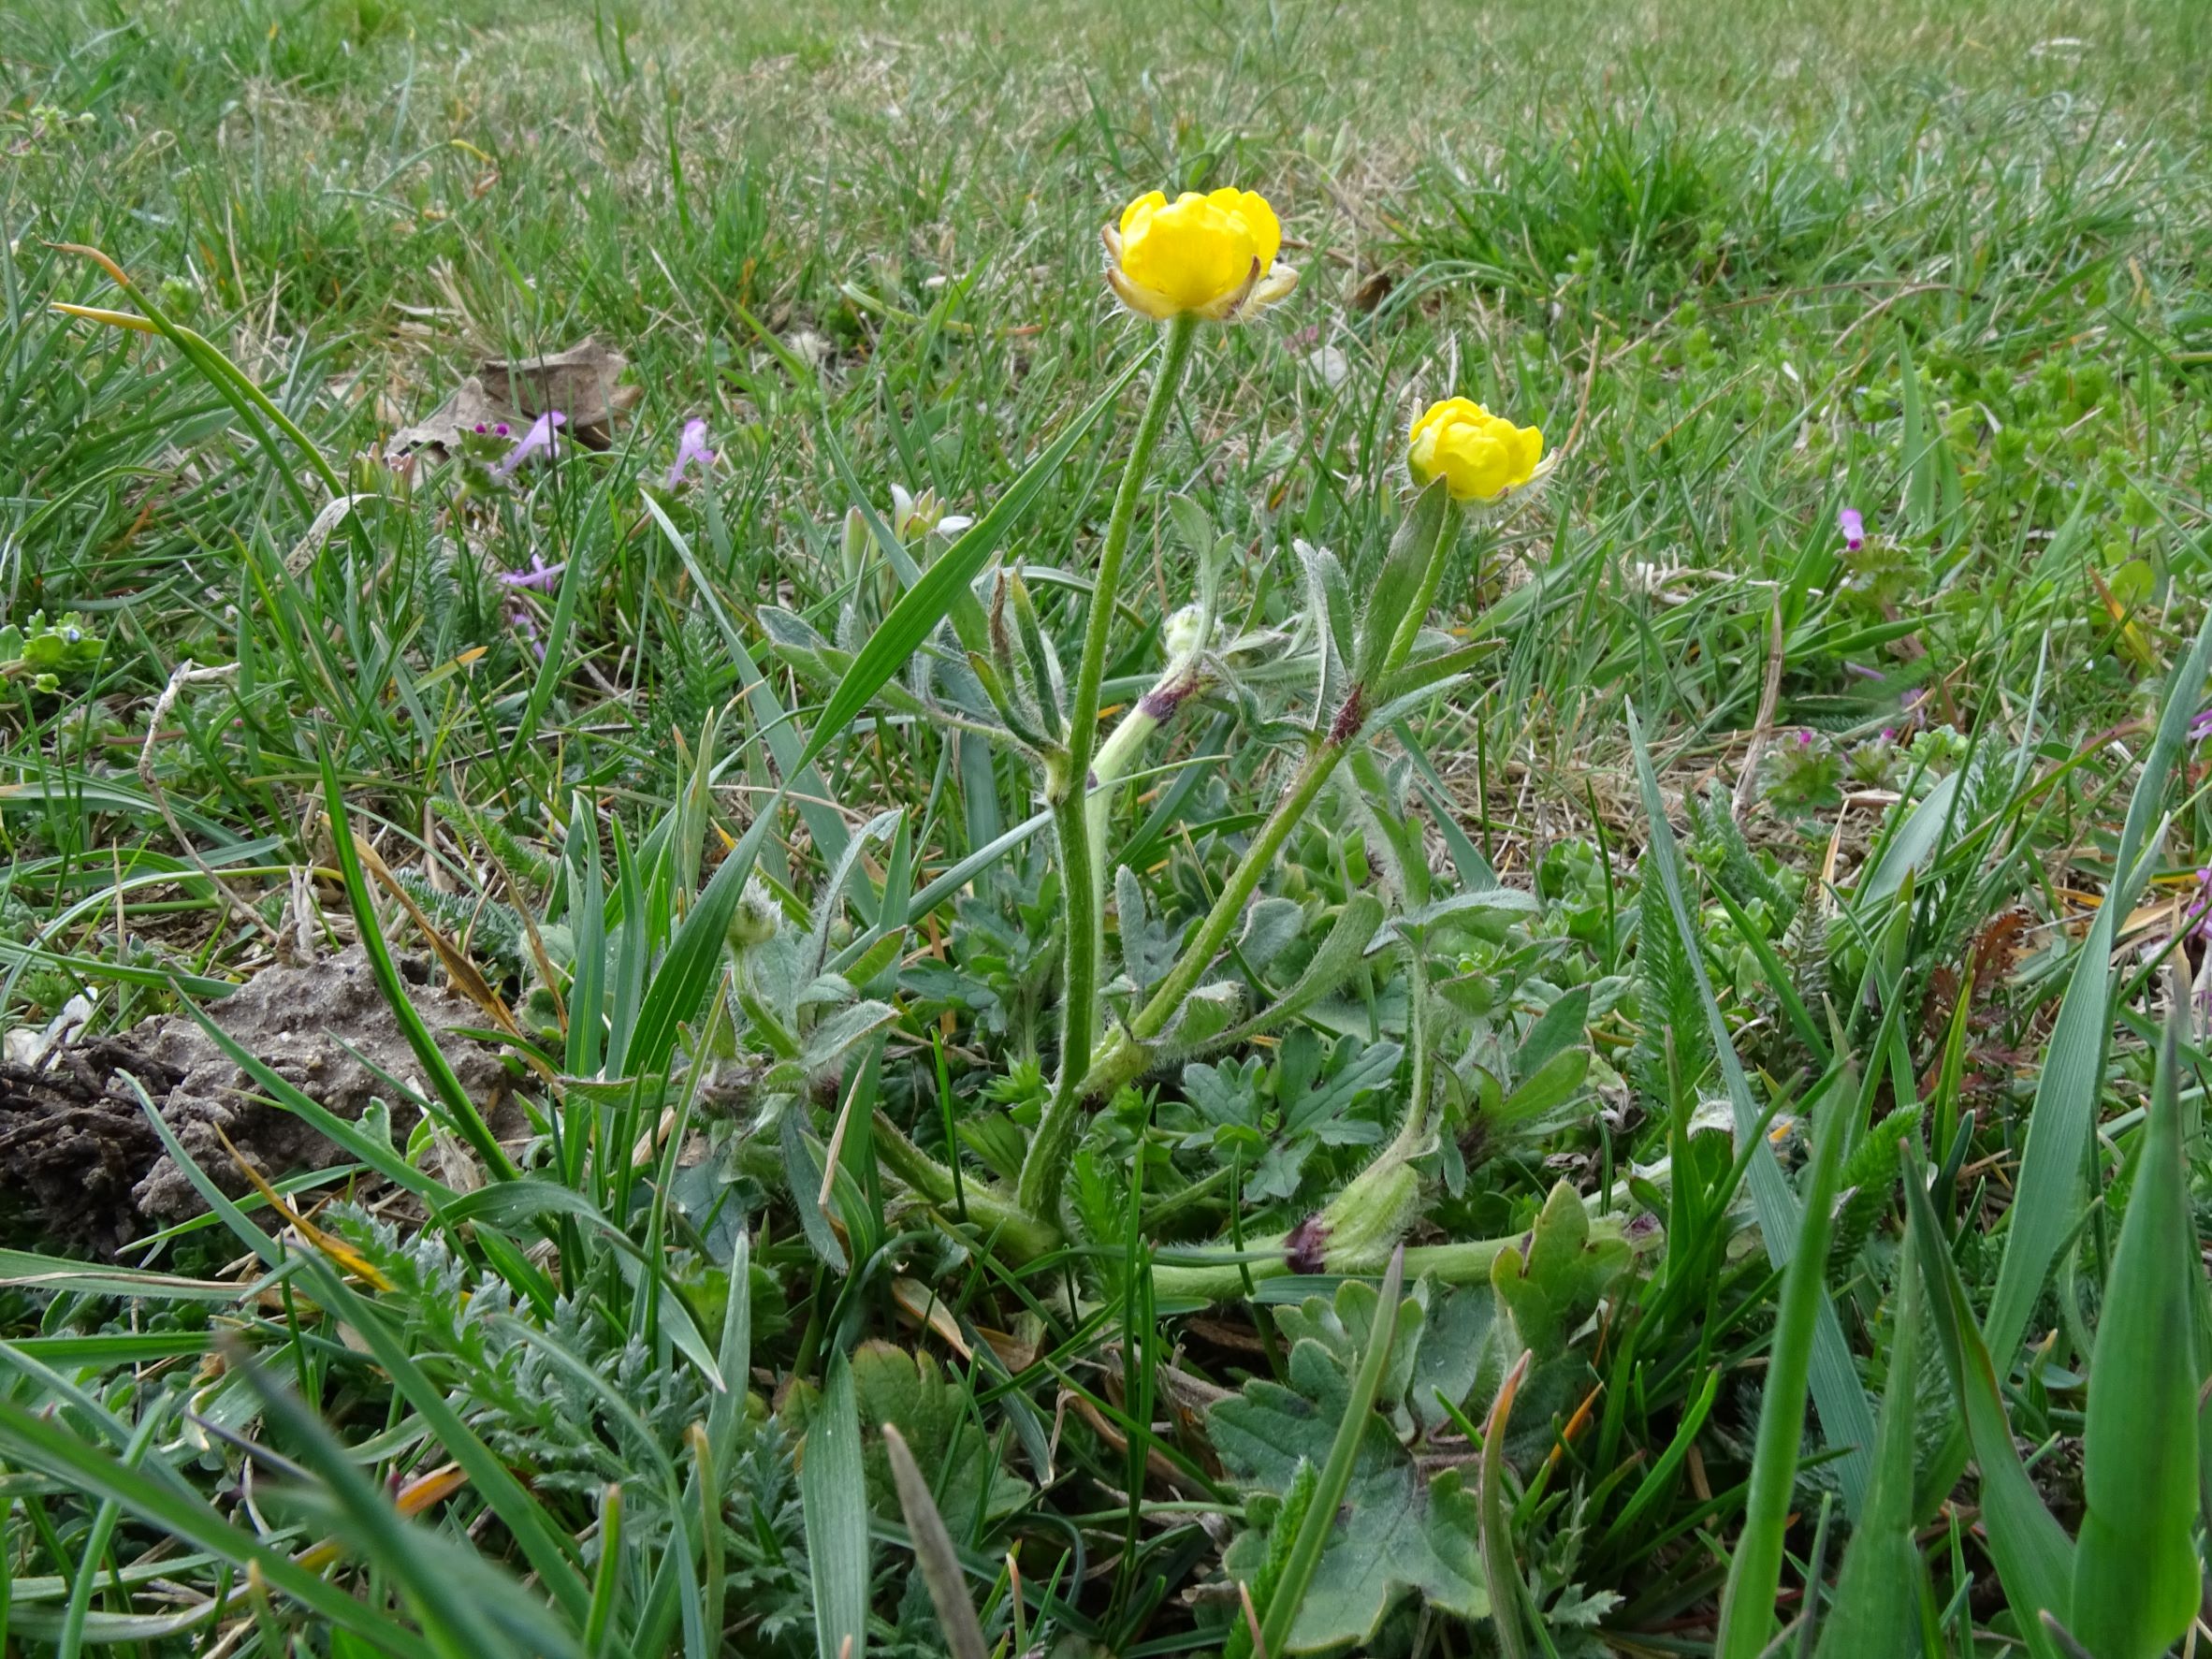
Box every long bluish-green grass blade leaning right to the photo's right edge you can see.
[1982,618,2212,1367]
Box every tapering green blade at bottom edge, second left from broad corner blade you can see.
[1816,1234,1927,1659]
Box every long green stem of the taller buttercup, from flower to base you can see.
[1015,316,1199,1223]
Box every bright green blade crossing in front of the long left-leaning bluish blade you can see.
[1712,1053,1855,1659]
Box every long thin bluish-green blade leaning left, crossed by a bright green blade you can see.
[1628,706,1873,1520]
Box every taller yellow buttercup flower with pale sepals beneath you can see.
[1106,190,1299,323]
